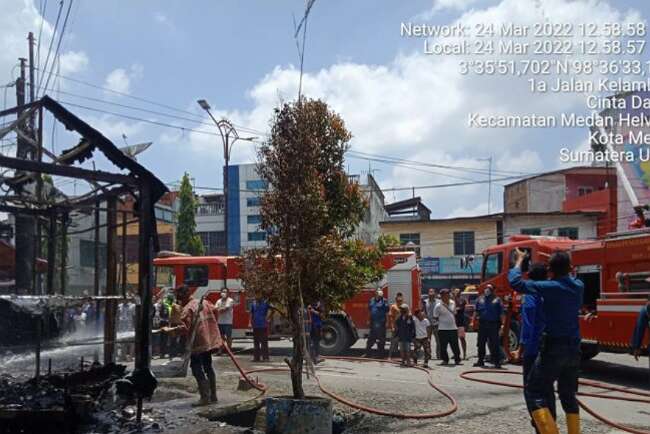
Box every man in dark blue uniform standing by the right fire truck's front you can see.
[474,284,504,369]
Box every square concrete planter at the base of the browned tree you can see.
[266,396,332,434]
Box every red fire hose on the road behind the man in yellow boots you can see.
[460,369,650,434]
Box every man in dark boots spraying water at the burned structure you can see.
[162,285,223,407]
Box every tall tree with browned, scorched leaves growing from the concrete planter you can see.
[242,100,386,398]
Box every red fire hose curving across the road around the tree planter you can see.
[224,346,458,419]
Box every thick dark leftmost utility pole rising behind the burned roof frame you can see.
[14,58,36,294]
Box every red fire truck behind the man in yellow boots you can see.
[479,229,650,359]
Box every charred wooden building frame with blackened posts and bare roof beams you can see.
[0,96,167,424]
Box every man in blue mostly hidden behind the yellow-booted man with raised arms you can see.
[519,262,557,431]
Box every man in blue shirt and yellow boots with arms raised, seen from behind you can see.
[508,249,584,434]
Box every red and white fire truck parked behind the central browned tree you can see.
[154,252,421,355]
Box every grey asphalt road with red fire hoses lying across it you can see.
[205,334,650,433]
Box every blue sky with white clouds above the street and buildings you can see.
[0,0,650,217]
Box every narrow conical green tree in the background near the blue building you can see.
[176,172,205,256]
